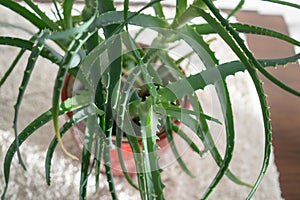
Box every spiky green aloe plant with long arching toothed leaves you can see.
[0,0,300,199]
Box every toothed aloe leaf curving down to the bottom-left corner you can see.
[1,94,89,199]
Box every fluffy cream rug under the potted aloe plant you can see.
[0,3,281,200]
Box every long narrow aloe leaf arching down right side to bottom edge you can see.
[201,0,272,199]
